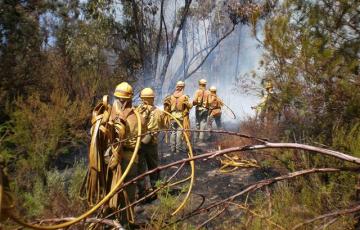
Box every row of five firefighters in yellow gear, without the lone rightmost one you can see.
[86,79,223,224]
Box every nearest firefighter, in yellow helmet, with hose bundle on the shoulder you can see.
[108,82,146,224]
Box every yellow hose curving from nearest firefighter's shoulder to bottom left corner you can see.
[10,110,141,229]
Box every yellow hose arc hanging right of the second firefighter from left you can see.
[162,110,195,215]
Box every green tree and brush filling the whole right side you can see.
[236,0,360,229]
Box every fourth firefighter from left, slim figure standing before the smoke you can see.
[193,79,210,145]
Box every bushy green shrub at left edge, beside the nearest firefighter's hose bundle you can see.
[0,90,90,220]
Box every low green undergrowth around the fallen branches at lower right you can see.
[220,121,360,229]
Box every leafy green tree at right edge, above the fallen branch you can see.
[255,0,360,140]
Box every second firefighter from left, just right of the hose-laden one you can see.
[136,88,165,197]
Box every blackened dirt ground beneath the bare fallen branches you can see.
[136,125,279,229]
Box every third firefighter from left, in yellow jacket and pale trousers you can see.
[164,81,192,153]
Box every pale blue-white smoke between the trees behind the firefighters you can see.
[117,1,263,121]
